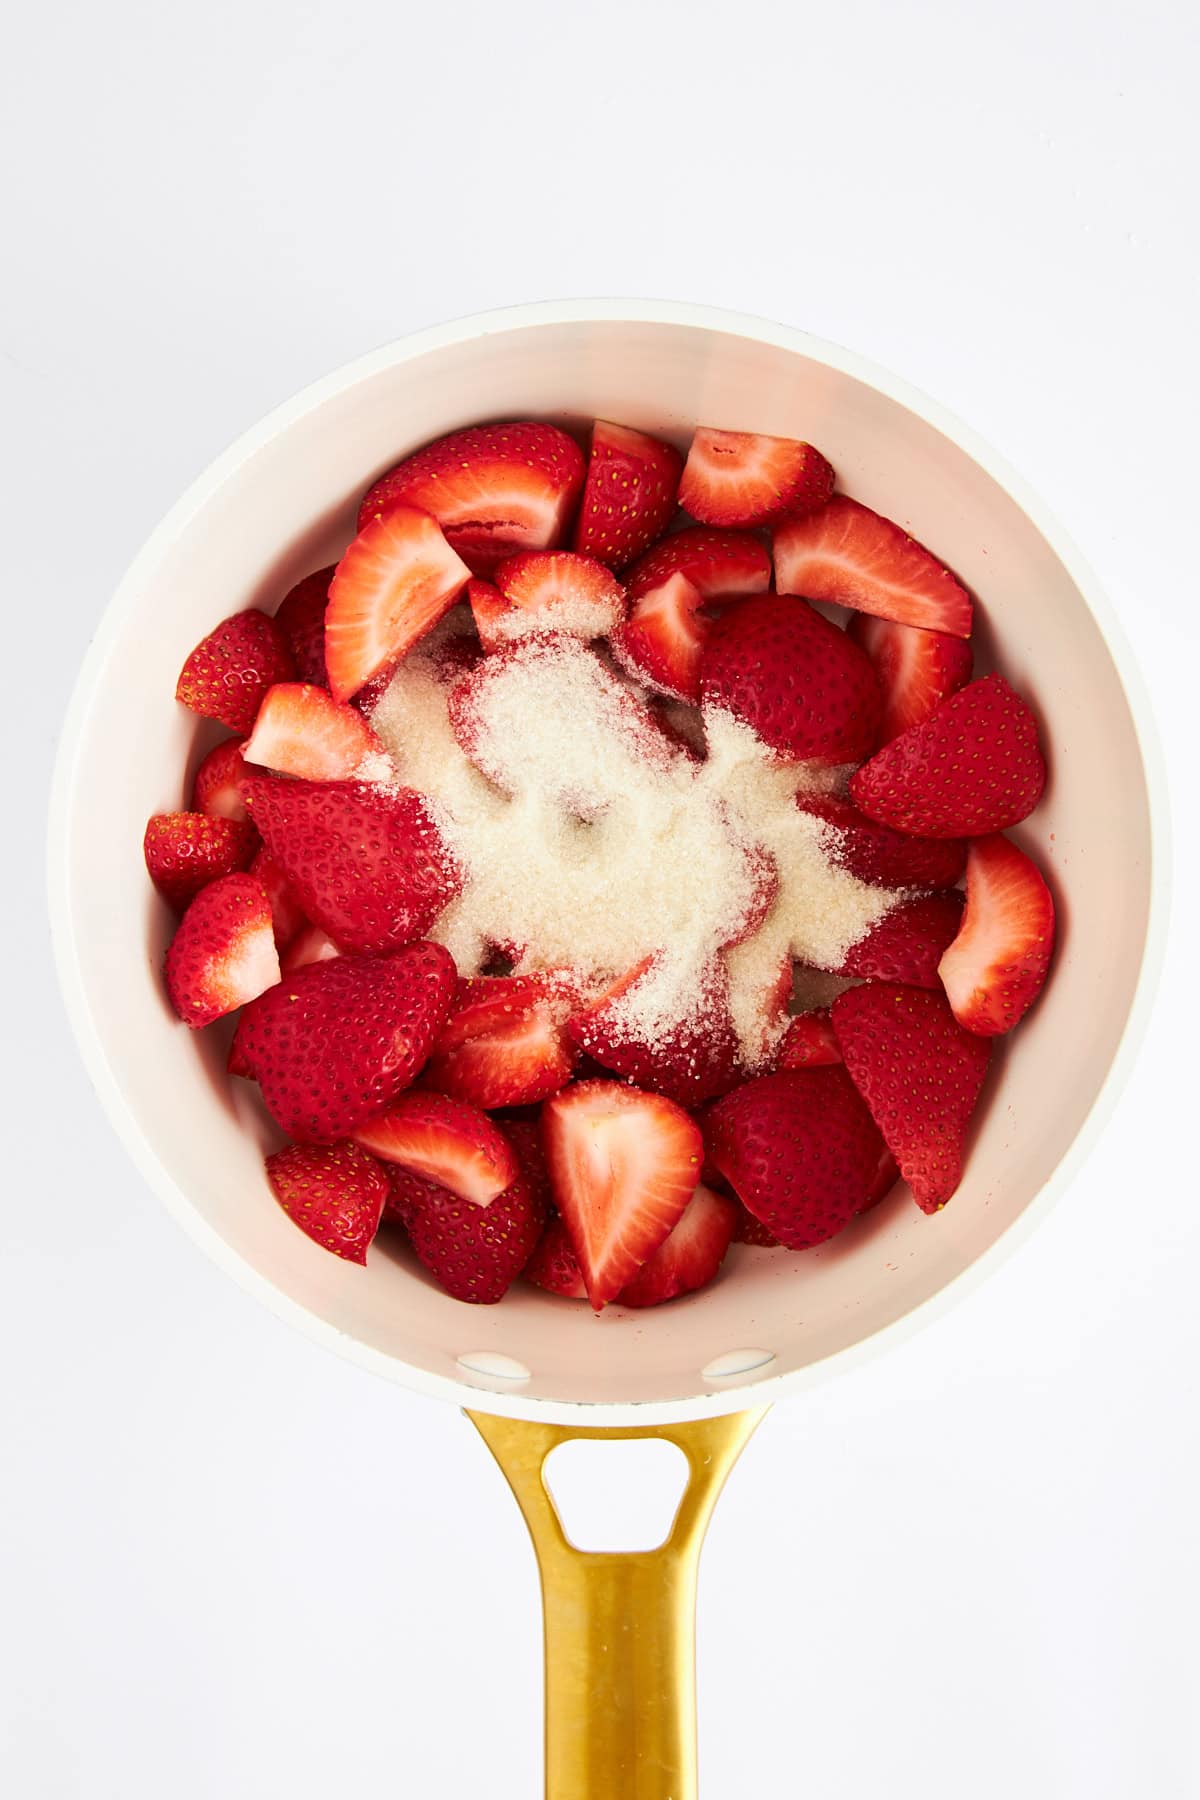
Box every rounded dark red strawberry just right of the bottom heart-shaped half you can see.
[703,1067,880,1249]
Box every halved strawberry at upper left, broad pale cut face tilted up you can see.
[326,506,471,700]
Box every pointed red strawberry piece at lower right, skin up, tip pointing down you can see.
[833,981,991,1213]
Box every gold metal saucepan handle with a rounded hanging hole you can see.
[468,1408,766,1800]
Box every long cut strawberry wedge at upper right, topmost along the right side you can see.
[772,493,972,637]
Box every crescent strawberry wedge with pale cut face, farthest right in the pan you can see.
[937,833,1054,1037]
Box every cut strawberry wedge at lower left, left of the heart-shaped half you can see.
[354,1089,516,1206]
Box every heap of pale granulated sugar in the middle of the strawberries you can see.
[372,637,903,1067]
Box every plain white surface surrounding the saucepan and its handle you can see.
[0,0,1200,1800]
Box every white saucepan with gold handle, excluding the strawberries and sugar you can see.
[50,301,1164,1800]
